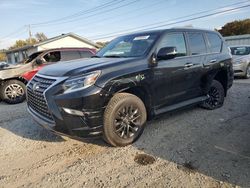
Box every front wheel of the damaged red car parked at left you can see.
[0,80,26,104]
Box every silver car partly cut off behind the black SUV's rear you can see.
[230,45,250,78]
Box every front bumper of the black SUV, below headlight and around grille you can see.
[27,74,110,138]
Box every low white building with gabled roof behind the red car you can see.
[6,33,100,63]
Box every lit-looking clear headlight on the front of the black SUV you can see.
[63,71,101,93]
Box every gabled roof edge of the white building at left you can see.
[6,33,100,53]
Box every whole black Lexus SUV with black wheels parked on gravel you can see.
[27,28,233,146]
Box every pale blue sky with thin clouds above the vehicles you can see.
[0,0,250,49]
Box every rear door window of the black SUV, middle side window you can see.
[187,33,207,55]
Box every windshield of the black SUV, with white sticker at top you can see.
[97,33,159,57]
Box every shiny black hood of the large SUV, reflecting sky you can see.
[38,58,137,77]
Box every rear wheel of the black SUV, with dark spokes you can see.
[201,80,225,110]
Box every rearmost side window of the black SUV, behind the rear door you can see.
[207,33,222,53]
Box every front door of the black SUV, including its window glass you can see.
[153,32,201,108]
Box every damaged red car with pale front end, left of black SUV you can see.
[0,48,96,104]
